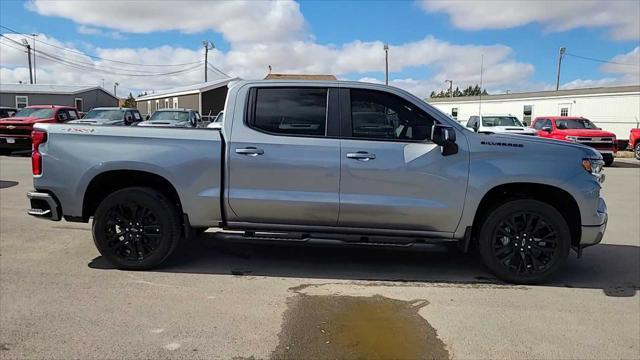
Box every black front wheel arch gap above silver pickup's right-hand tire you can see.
[472,182,582,246]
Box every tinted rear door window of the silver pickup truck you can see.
[251,88,327,136]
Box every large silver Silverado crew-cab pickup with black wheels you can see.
[28,81,607,283]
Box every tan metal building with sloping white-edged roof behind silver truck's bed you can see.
[136,78,238,120]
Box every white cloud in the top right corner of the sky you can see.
[420,0,640,40]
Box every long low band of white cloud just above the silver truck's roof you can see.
[0,31,534,96]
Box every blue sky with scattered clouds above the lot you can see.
[0,1,640,95]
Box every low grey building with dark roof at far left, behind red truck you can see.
[0,84,118,111]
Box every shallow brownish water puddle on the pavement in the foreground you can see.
[271,294,449,359]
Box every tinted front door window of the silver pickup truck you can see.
[351,89,434,141]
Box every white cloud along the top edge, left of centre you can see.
[27,0,305,43]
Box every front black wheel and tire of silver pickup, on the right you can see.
[478,199,571,284]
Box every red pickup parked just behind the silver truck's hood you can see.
[531,116,618,166]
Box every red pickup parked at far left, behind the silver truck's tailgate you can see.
[0,105,80,155]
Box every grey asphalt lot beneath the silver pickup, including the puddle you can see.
[0,156,640,359]
